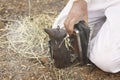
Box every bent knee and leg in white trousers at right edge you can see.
[90,0,120,73]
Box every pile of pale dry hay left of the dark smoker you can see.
[0,14,54,63]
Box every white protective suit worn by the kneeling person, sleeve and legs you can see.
[53,0,120,73]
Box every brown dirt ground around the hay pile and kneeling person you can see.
[0,0,120,80]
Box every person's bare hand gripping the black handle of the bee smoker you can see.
[64,0,88,34]
